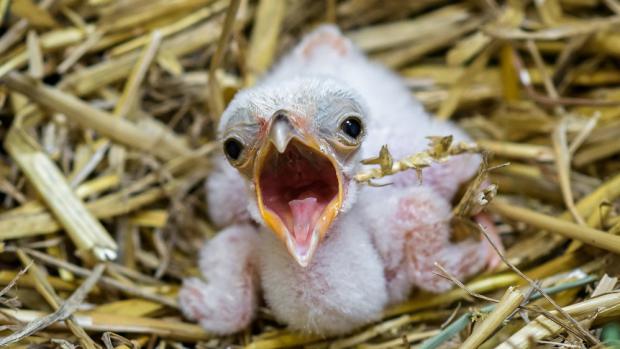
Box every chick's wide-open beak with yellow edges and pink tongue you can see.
[254,118,343,267]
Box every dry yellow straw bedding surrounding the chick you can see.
[0,0,620,349]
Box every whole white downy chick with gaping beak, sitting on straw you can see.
[179,26,497,335]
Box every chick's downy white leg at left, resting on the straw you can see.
[179,224,258,334]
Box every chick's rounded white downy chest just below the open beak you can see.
[259,218,387,332]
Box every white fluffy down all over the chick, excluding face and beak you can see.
[180,26,493,334]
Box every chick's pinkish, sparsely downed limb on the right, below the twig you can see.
[367,187,490,302]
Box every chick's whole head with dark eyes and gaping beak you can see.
[219,78,366,266]
